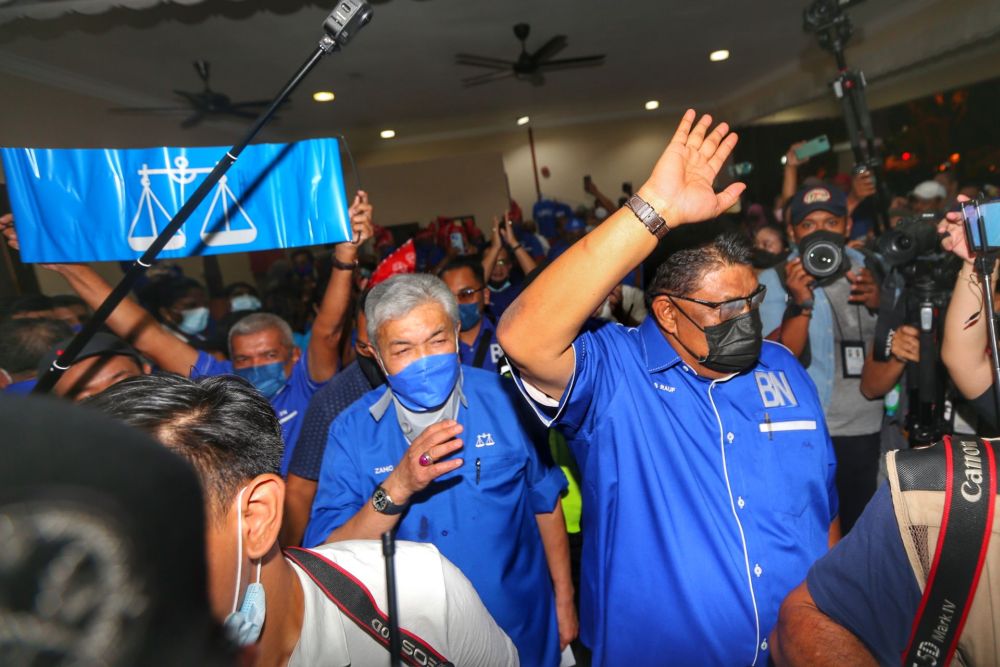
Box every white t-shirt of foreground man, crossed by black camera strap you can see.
[288,540,519,667]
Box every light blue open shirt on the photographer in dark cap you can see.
[757,247,865,410]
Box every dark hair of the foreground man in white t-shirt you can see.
[84,374,284,516]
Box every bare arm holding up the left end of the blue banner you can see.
[0,214,198,376]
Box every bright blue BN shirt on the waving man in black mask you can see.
[522,317,837,665]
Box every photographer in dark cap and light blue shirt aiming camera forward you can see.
[759,185,882,533]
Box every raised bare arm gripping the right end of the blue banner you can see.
[308,190,374,382]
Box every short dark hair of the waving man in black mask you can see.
[646,232,750,307]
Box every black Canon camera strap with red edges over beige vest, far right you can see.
[896,436,997,667]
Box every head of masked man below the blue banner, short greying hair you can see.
[229,313,301,398]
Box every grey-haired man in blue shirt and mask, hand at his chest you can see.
[303,274,577,666]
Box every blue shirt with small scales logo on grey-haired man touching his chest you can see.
[303,367,566,666]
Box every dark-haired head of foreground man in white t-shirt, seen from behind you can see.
[85,375,284,620]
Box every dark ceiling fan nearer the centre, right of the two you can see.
[455,23,604,87]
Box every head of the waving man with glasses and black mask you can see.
[646,233,764,377]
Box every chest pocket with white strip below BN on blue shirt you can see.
[755,410,826,517]
